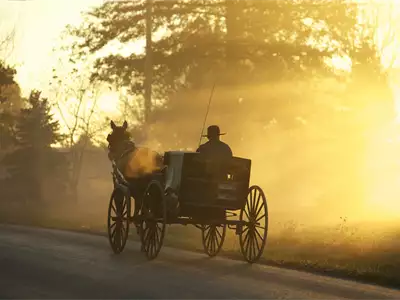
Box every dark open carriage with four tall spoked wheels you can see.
[108,151,268,262]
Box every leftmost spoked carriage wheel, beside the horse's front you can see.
[107,189,131,254]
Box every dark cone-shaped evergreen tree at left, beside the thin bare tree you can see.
[3,91,67,202]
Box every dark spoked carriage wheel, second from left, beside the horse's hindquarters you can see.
[140,181,167,259]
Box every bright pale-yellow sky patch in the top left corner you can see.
[0,0,104,94]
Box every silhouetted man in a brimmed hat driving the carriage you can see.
[196,125,233,159]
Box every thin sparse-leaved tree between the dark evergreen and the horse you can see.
[51,52,109,203]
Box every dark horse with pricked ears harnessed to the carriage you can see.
[107,120,163,224]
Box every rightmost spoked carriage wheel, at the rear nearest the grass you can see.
[239,186,268,263]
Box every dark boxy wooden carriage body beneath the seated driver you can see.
[164,151,251,212]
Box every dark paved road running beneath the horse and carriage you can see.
[0,225,400,300]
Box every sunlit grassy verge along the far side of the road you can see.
[0,203,400,288]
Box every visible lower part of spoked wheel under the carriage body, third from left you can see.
[201,224,226,257]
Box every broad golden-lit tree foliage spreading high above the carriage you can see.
[68,0,357,125]
